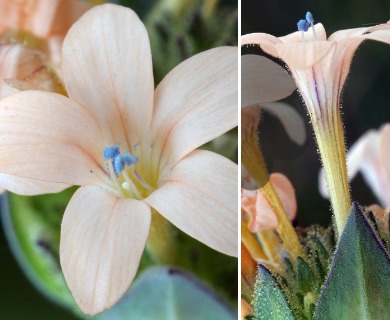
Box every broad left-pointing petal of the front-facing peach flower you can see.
[0,91,108,185]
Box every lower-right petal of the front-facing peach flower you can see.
[145,150,238,257]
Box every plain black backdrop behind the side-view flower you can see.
[241,0,390,226]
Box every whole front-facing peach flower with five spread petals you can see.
[0,4,238,314]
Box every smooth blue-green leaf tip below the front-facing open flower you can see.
[98,267,237,320]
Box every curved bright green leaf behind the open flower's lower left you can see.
[1,189,80,315]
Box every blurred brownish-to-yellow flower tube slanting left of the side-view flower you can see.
[241,129,304,261]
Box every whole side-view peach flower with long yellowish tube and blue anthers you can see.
[241,13,390,232]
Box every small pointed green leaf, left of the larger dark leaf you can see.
[253,265,295,320]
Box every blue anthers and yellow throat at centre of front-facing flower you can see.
[103,146,154,200]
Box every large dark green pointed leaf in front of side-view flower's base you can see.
[315,203,390,320]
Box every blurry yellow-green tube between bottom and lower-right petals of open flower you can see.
[146,209,177,264]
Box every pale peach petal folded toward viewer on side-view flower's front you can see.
[275,41,335,69]
